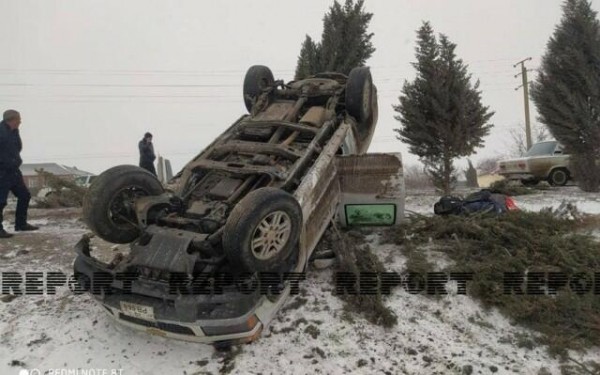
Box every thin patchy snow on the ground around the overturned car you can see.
[0,188,600,375]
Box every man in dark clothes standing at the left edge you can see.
[0,109,38,238]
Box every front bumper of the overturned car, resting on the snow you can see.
[74,238,290,345]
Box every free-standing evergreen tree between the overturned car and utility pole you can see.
[394,22,494,194]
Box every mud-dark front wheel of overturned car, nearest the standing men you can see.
[83,165,164,243]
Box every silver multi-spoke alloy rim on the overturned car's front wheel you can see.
[251,211,292,260]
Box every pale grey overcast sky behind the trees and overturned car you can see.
[0,0,598,173]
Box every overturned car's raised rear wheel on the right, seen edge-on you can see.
[346,67,373,126]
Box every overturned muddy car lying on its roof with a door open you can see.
[74,66,404,345]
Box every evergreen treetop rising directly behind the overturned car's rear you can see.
[296,0,375,79]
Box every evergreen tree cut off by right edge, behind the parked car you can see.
[531,0,600,191]
